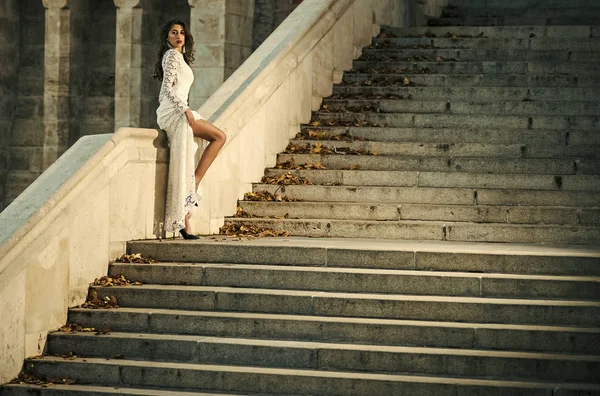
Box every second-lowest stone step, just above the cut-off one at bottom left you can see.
[21,357,600,396]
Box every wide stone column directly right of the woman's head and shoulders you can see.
[188,0,254,109]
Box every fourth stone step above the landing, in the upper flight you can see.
[265,168,600,192]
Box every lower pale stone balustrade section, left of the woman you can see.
[0,128,168,383]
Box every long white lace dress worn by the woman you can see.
[156,49,204,232]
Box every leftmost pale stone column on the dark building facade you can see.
[42,0,71,169]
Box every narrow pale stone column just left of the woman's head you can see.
[114,0,142,131]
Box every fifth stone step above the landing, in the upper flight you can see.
[268,153,598,174]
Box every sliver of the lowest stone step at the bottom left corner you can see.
[0,383,241,396]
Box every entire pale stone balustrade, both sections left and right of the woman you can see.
[0,0,447,383]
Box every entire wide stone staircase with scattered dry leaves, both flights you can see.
[0,0,600,396]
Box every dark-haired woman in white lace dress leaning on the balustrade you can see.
[152,19,226,239]
